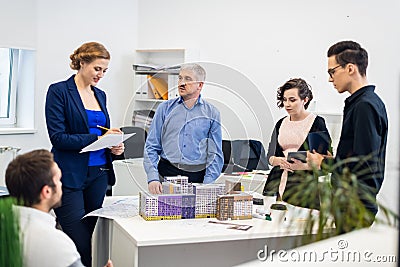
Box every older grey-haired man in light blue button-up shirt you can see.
[144,64,223,194]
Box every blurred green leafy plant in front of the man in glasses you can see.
[287,156,399,243]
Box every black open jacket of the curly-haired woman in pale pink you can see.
[263,116,332,208]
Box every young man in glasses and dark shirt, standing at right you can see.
[308,41,388,232]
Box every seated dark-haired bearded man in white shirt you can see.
[5,149,113,267]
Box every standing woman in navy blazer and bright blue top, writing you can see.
[45,42,124,266]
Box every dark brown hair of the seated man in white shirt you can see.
[6,149,55,207]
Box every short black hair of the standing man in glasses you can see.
[328,41,368,76]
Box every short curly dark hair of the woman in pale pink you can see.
[276,78,314,109]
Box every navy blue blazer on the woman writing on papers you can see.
[45,75,115,188]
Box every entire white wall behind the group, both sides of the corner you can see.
[0,0,400,215]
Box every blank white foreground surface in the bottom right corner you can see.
[238,224,399,267]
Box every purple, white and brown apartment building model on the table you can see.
[139,176,253,220]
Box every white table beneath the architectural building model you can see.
[93,197,328,267]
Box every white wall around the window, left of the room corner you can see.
[0,0,137,152]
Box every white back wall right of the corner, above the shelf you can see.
[138,0,400,214]
